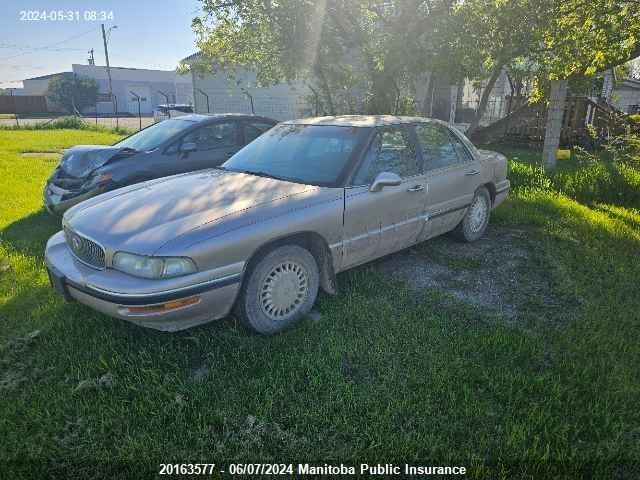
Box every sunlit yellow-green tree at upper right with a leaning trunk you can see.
[451,0,640,171]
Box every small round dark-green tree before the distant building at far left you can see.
[45,73,98,114]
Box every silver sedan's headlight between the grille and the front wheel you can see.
[112,252,197,279]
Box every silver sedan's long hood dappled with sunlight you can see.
[63,170,319,255]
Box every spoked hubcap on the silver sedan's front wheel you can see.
[259,261,308,320]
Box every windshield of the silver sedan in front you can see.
[222,124,368,186]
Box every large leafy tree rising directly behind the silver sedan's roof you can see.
[193,0,453,114]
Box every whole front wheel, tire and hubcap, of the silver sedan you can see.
[236,245,320,335]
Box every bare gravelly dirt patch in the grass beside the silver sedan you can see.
[373,226,562,320]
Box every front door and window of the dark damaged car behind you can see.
[176,121,241,172]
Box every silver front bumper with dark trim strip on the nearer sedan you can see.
[46,232,241,331]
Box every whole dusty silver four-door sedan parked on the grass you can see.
[46,116,510,334]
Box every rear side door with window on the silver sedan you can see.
[416,123,482,241]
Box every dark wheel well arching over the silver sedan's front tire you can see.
[243,232,337,295]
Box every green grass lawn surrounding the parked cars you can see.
[0,130,640,479]
